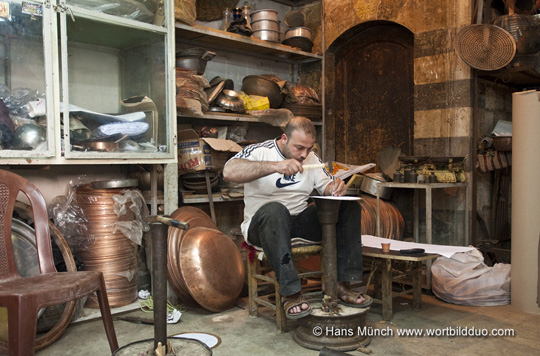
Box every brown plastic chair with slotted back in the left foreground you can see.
[0,170,118,356]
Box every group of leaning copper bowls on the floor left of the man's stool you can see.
[167,206,245,312]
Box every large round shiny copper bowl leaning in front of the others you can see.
[180,227,245,312]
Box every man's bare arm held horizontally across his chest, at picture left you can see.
[223,158,303,183]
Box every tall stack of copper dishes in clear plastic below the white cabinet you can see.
[76,180,138,308]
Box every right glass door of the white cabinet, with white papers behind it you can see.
[59,1,173,159]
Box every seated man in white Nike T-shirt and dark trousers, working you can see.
[223,117,372,319]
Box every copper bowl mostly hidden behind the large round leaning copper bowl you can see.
[167,205,217,306]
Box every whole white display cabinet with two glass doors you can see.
[0,0,176,164]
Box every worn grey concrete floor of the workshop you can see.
[36,295,540,356]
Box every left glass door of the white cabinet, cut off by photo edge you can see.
[0,1,55,159]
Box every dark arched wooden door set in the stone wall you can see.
[329,22,414,164]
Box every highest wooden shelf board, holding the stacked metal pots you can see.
[175,22,322,63]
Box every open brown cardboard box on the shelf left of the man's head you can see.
[178,129,242,175]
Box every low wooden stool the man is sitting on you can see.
[247,245,322,333]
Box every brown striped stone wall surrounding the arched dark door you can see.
[315,0,476,244]
